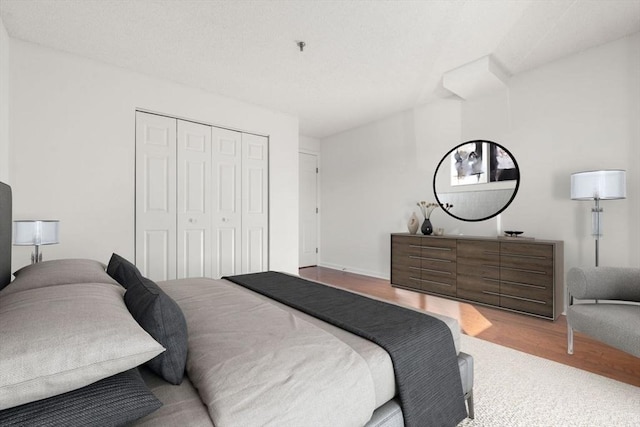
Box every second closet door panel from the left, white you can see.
[177,120,211,279]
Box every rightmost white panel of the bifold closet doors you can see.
[242,133,269,273]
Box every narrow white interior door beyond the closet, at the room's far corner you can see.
[298,153,318,267]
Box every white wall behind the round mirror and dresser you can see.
[321,34,640,278]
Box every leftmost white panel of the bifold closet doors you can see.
[135,112,176,280]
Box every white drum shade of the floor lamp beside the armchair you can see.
[571,169,627,200]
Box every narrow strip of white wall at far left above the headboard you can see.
[0,18,10,183]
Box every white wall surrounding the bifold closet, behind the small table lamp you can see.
[10,40,298,273]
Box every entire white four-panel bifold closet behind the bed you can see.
[135,111,269,280]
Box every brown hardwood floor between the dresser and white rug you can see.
[300,267,640,387]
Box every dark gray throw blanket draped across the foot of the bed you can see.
[224,271,467,427]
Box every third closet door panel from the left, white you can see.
[211,127,242,278]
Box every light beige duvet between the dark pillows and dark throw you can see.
[160,279,380,427]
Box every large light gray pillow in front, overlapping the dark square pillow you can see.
[0,283,164,410]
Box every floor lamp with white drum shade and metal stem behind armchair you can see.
[571,169,627,267]
